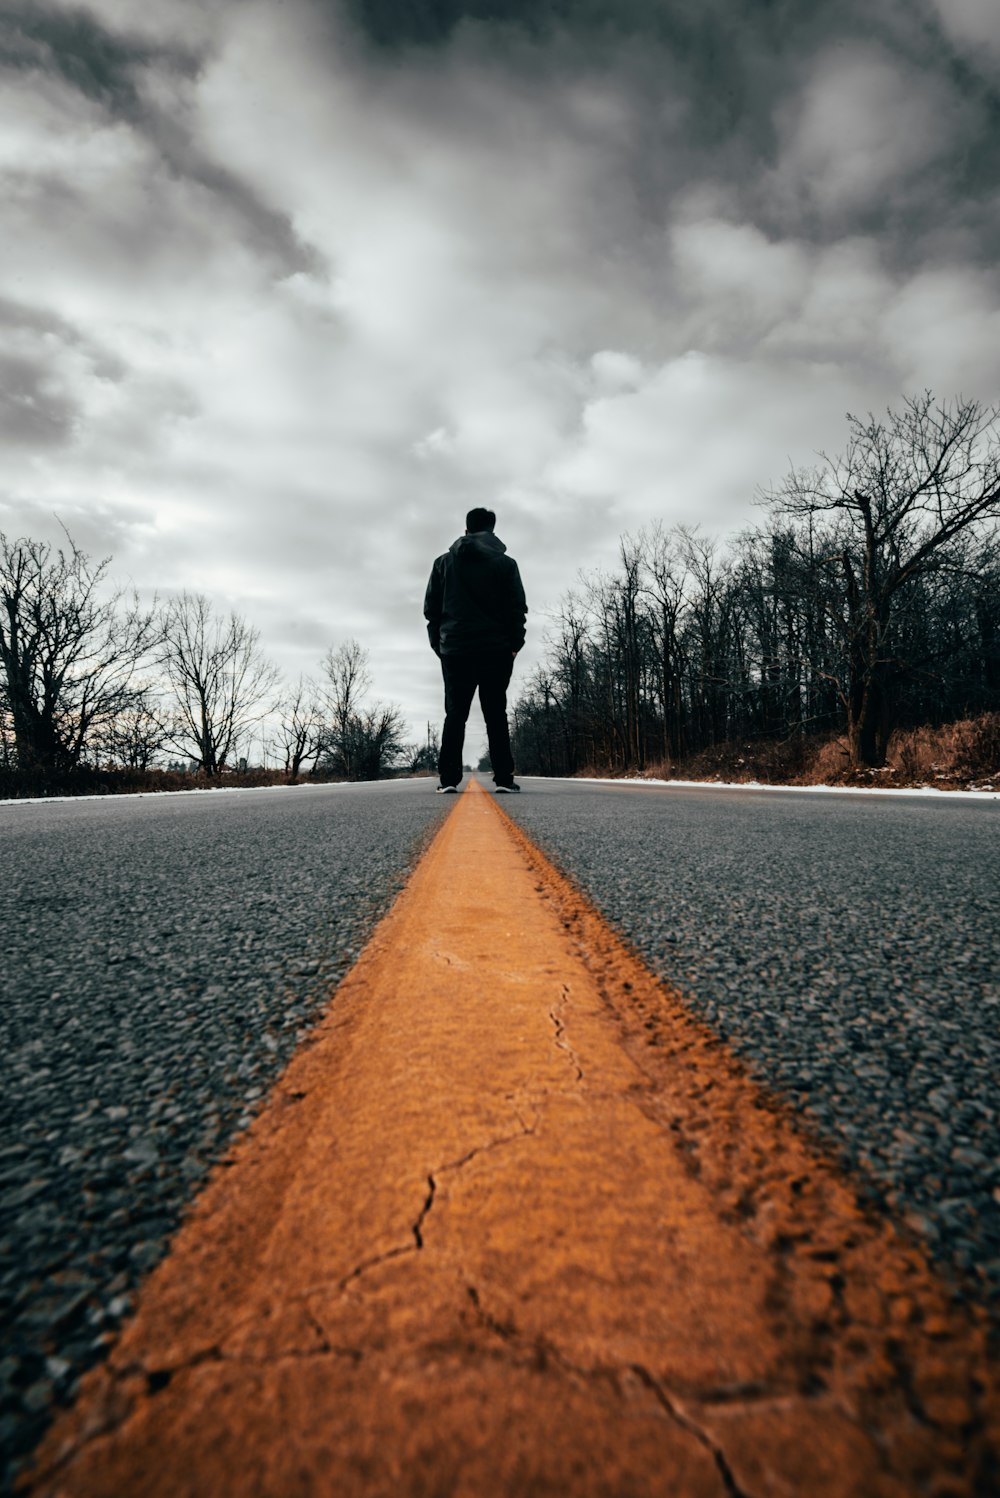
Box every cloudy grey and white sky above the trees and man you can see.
[0,0,1000,749]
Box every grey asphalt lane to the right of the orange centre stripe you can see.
[503,780,1000,1311]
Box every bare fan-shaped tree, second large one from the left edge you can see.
[160,593,278,776]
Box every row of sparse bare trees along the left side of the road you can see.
[0,545,413,780]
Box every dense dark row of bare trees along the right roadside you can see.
[512,392,1000,774]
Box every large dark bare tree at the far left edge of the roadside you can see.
[0,533,156,770]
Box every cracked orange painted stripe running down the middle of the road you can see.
[31,786,1000,1498]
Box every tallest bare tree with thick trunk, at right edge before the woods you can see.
[766,391,1000,767]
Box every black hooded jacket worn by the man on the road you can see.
[424,530,528,655]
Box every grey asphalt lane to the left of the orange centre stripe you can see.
[0,780,454,1491]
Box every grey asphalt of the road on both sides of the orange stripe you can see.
[0,780,1000,1488]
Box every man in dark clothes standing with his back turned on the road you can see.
[424,509,528,792]
